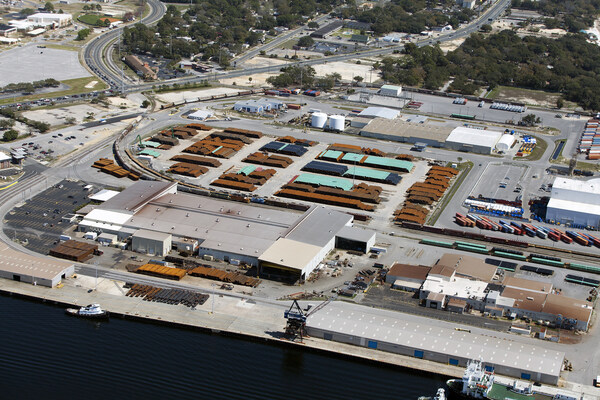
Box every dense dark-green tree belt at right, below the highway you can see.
[379,30,600,110]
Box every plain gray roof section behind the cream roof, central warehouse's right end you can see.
[285,206,352,246]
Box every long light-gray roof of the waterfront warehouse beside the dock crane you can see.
[307,302,565,376]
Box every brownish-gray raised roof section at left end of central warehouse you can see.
[98,181,177,212]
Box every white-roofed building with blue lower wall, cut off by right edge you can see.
[546,178,600,228]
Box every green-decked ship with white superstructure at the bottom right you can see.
[446,360,553,400]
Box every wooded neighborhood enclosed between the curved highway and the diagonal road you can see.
[123,0,342,67]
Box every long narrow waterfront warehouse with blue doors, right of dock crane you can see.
[306,301,565,385]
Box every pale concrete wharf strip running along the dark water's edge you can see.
[0,278,600,400]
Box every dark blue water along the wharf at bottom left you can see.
[0,296,444,400]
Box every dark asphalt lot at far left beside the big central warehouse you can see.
[4,180,89,254]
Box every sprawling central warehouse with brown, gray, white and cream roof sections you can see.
[79,181,375,279]
